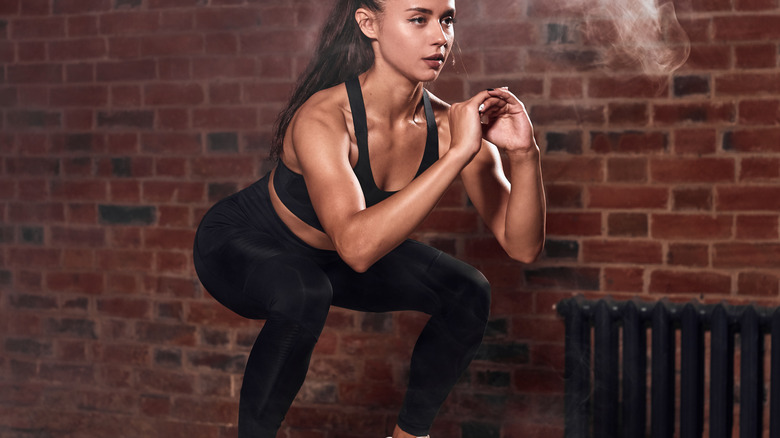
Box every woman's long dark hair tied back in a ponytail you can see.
[271,0,384,158]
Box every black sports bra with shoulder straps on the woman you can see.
[274,78,439,231]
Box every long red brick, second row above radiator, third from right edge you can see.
[582,240,663,264]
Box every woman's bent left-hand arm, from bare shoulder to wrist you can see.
[292,91,486,272]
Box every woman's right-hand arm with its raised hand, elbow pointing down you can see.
[460,89,546,263]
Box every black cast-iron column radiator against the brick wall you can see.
[556,297,780,438]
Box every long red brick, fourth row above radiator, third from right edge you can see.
[588,186,669,209]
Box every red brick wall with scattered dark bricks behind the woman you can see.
[0,0,780,438]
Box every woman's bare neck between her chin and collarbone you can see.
[360,66,423,124]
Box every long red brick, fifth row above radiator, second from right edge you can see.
[650,158,736,183]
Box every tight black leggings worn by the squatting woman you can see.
[194,177,490,438]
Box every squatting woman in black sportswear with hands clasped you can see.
[194,0,545,438]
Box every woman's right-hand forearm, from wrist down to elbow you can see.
[503,148,546,263]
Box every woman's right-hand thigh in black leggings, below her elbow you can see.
[327,240,487,314]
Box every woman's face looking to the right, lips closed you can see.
[376,0,455,82]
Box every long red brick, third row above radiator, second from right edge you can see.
[652,214,734,240]
